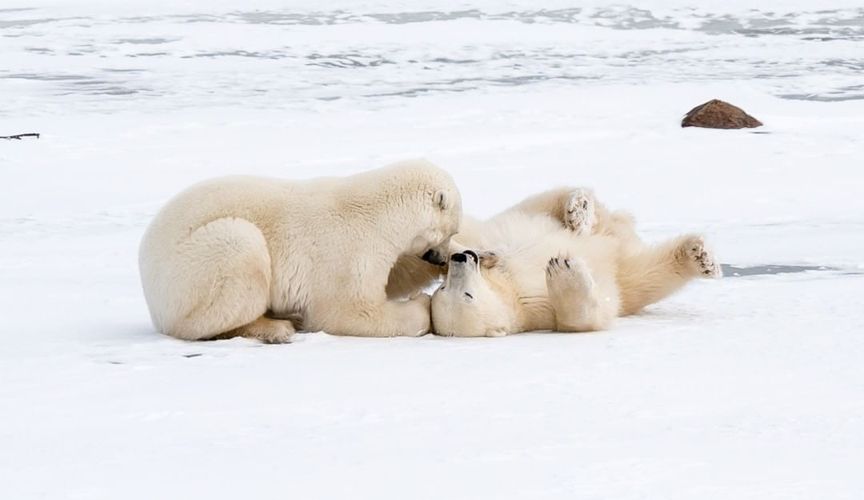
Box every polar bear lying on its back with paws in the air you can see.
[432,188,721,337]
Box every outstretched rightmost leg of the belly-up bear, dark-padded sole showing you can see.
[618,235,722,315]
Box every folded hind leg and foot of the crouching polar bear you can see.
[161,218,293,343]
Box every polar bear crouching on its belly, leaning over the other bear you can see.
[139,160,462,343]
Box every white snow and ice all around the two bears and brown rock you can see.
[0,0,864,500]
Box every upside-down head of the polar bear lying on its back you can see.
[432,250,515,337]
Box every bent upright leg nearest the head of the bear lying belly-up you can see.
[546,257,618,332]
